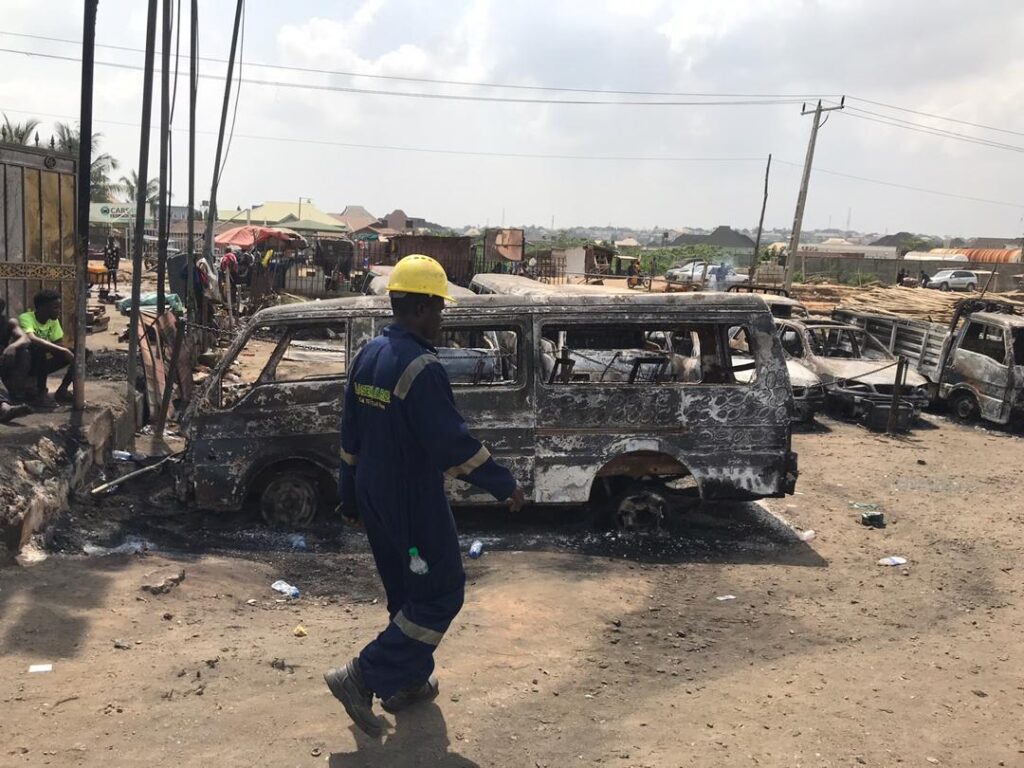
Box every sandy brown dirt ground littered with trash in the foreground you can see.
[0,417,1024,768]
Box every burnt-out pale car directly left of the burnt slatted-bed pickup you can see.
[775,318,930,419]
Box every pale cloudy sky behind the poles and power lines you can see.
[0,0,1024,237]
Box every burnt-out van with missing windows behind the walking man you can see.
[177,294,797,529]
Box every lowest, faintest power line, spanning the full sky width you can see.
[6,108,1024,208]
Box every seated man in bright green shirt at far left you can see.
[17,289,75,404]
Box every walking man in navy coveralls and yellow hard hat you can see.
[324,255,524,736]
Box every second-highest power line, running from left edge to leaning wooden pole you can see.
[0,48,815,106]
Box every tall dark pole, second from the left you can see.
[127,0,157,427]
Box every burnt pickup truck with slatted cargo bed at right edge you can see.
[833,299,1024,424]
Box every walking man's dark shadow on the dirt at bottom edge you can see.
[329,701,479,768]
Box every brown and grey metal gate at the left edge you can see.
[0,144,80,339]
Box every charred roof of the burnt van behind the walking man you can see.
[253,293,768,325]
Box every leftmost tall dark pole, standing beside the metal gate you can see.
[73,0,99,411]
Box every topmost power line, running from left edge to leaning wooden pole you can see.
[0,31,841,103]
